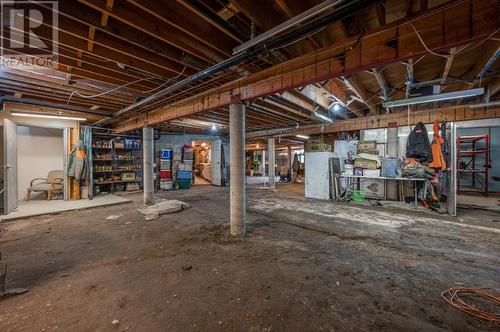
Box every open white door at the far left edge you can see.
[3,119,18,214]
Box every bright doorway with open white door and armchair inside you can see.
[0,124,66,214]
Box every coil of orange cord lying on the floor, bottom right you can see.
[441,287,500,324]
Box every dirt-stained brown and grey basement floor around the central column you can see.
[0,184,500,332]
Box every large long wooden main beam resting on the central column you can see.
[115,0,500,131]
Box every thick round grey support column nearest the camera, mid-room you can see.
[229,103,247,236]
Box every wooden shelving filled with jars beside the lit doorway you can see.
[92,129,143,196]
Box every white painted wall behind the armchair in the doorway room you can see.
[17,126,64,200]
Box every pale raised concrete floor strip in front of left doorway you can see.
[0,195,131,222]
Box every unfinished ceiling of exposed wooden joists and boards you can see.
[0,0,499,132]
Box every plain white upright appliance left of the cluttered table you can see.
[305,152,333,200]
